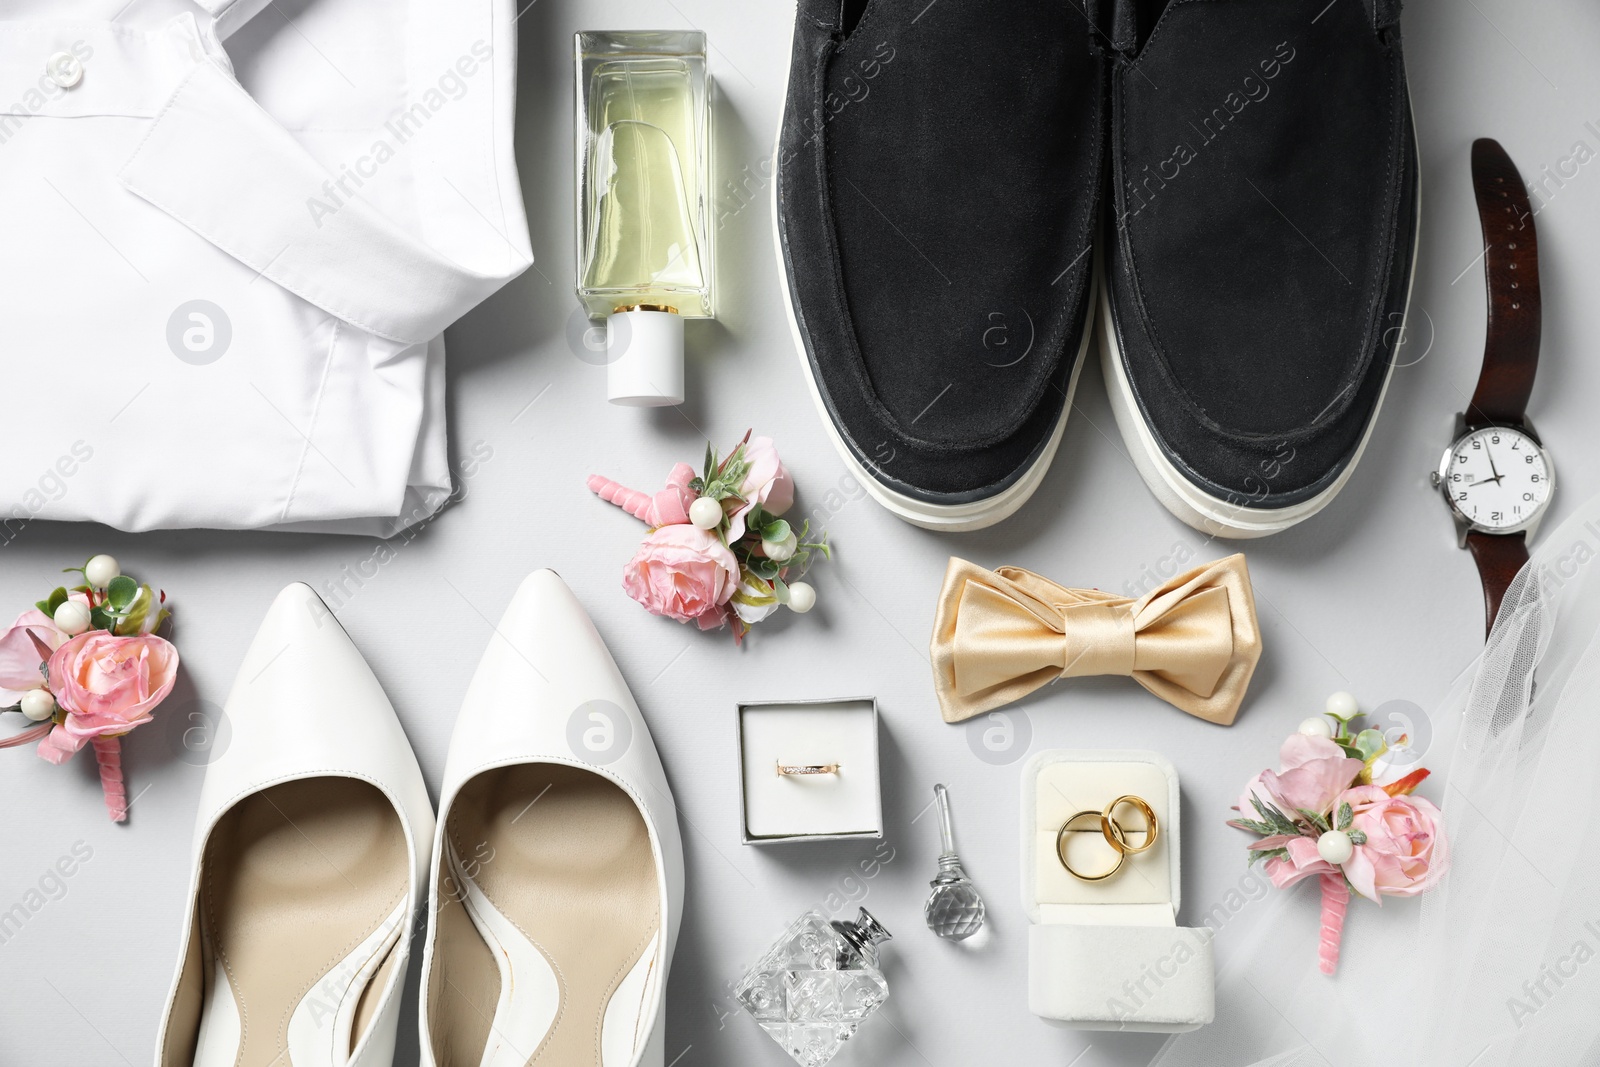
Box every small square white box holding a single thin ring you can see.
[738,697,883,845]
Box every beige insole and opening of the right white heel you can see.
[430,763,661,1067]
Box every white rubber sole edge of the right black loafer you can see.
[1099,143,1422,539]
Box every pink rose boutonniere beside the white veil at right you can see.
[1229,693,1450,974]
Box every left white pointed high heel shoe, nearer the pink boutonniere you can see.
[155,584,434,1067]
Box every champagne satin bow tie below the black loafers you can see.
[931,555,1261,726]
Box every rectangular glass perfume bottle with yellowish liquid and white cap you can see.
[576,30,714,406]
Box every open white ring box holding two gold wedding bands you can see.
[1022,749,1216,1033]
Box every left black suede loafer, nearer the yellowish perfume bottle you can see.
[773,0,1107,530]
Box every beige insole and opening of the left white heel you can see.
[194,777,410,1067]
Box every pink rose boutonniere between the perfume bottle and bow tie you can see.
[589,434,832,641]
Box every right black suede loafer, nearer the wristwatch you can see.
[1101,0,1418,537]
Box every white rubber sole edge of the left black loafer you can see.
[771,89,1101,533]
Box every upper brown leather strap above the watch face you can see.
[1466,138,1539,430]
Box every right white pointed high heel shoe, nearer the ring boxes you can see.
[421,571,683,1067]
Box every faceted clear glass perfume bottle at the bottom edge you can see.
[733,909,890,1067]
